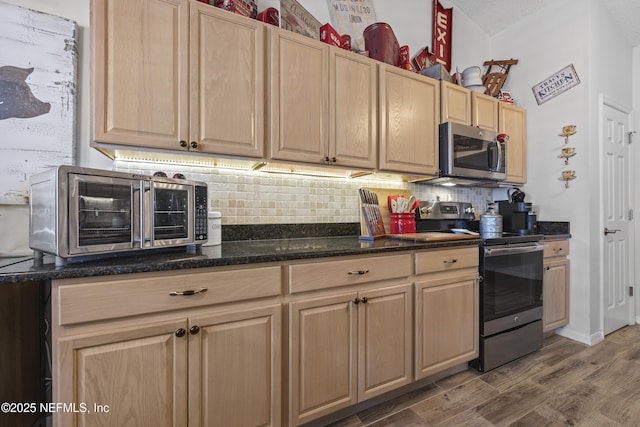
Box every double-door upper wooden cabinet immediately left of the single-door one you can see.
[269,29,377,169]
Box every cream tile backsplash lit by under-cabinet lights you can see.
[114,160,492,225]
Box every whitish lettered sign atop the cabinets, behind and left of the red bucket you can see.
[327,0,377,50]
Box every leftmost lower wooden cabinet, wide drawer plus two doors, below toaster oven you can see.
[52,267,282,427]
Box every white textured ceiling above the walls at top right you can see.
[449,0,640,47]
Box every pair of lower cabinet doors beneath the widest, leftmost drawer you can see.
[58,305,281,427]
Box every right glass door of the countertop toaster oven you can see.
[143,181,195,247]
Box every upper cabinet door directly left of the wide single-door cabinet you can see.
[329,47,378,169]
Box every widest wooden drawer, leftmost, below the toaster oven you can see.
[54,266,282,325]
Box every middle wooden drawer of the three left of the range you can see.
[289,254,412,293]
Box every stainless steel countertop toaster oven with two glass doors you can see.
[29,166,207,263]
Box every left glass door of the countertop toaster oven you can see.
[68,174,141,255]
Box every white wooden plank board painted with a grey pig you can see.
[0,3,77,204]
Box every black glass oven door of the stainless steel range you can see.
[480,243,546,336]
